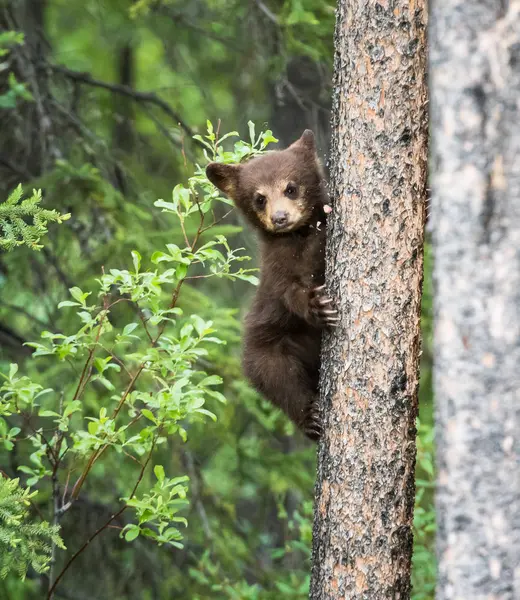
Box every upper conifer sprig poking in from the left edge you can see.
[0,184,70,250]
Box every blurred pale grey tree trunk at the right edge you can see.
[431,0,520,600]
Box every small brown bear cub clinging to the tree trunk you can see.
[206,129,338,440]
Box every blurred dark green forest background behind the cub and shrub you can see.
[0,0,435,600]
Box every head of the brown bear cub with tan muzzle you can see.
[206,129,325,234]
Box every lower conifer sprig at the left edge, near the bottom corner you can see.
[0,476,65,579]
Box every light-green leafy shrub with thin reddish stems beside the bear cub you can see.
[0,122,276,592]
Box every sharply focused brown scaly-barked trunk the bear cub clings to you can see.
[311,0,427,600]
